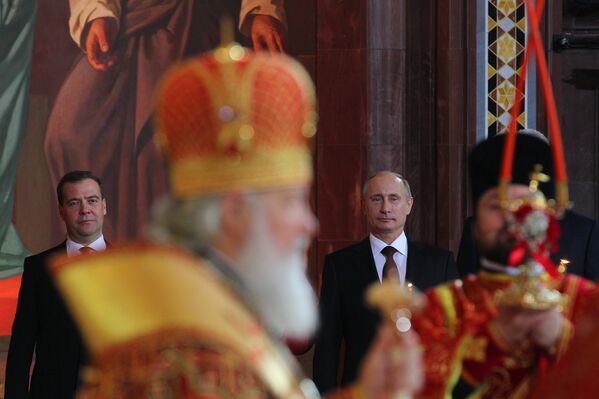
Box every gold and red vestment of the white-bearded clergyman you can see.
[52,244,359,399]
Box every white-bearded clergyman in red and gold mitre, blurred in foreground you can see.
[48,38,421,399]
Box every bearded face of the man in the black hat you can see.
[473,184,529,265]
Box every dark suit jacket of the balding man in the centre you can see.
[314,238,458,392]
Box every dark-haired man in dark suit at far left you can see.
[4,171,106,399]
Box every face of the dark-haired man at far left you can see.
[58,179,106,245]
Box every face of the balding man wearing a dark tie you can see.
[363,175,413,241]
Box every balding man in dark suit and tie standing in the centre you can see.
[314,171,458,392]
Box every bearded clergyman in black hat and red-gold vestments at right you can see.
[413,134,596,398]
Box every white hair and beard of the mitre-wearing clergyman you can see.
[146,193,318,338]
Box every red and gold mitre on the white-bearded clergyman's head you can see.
[156,43,317,197]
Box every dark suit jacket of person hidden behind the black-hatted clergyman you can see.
[457,211,599,281]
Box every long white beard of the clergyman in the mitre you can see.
[235,206,318,339]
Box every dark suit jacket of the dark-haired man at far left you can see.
[4,242,84,399]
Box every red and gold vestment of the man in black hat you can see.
[413,272,597,398]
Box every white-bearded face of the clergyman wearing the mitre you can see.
[238,187,318,338]
